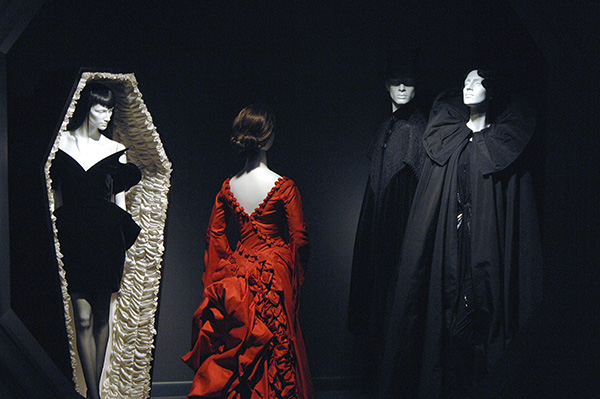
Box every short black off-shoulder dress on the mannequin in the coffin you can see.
[50,149,141,296]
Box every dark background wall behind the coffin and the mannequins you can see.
[6,0,600,396]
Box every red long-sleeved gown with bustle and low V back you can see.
[183,177,314,399]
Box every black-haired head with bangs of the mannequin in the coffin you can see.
[68,82,116,131]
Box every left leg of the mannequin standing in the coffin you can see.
[72,294,100,399]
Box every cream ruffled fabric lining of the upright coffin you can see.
[44,72,172,399]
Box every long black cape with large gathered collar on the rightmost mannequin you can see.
[379,92,542,398]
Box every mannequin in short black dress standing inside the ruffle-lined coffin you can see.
[51,82,141,399]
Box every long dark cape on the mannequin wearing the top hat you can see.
[348,102,427,385]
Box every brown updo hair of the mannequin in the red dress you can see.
[231,104,275,157]
